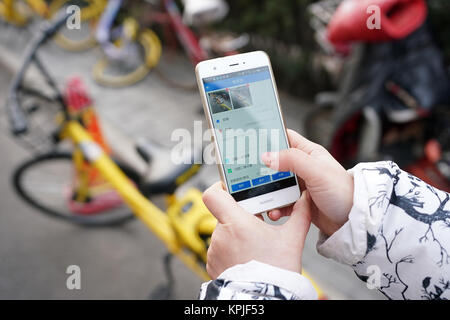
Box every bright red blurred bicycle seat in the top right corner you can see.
[327,0,427,48]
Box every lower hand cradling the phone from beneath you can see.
[203,182,311,279]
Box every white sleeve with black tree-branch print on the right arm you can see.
[317,162,450,299]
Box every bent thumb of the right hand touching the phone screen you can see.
[261,148,322,181]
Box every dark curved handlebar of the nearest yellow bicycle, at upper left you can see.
[6,13,71,135]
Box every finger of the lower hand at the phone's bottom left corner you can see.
[202,182,251,223]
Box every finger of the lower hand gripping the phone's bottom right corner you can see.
[283,190,311,241]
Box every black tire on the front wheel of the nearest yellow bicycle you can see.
[12,152,134,227]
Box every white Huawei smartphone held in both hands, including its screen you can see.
[196,51,300,214]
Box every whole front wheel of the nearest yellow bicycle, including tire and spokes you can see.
[13,152,134,226]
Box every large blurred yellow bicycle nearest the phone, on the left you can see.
[7,16,324,298]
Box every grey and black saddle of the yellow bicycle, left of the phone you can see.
[136,139,202,196]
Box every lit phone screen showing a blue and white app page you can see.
[203,67,297,201]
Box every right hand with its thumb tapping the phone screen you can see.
[261,130,353,236]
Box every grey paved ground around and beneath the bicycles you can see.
[0,21,381,299]
